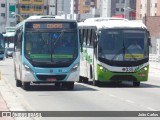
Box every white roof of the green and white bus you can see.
[78,18,146,29]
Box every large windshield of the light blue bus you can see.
[24,30,78,64]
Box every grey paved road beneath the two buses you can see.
[0,58,160,120]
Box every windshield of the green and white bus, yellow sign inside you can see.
[98,29,148,61]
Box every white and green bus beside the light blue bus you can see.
[78,18,150,87]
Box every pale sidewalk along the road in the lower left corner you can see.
[0,71,36,120]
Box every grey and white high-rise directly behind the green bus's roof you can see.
[97,0,136,19]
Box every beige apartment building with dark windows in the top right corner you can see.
[136,0,160,19]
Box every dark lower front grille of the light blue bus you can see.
[37,75,66,80]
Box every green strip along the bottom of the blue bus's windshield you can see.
[30,54,73,58]
